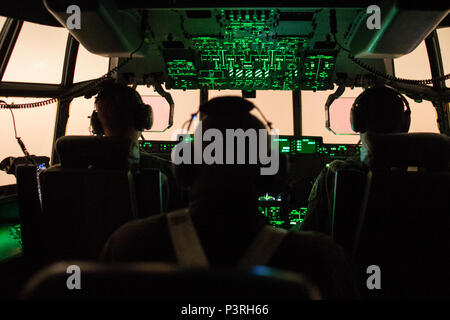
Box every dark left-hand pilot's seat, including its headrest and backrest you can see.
[40,136,137,261]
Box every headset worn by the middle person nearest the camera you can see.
[174,96,288,188]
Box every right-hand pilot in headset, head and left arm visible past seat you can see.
[301,86,411,234]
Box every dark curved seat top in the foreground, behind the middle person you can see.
[22,261,321,302]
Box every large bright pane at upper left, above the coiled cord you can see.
[2,22,68,83]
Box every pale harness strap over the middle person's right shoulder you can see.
[238,226,288,268]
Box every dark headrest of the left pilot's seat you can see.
[56,136,139,170]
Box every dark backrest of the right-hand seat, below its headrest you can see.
[354,172,450,298]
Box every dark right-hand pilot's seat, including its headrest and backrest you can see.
[334,134,450,298]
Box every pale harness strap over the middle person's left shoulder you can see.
[167,210,209,268]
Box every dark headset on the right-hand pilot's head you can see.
[350,86,411,133]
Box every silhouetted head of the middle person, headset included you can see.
[172,96,279,193]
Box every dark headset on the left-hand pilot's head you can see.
[90,82,153,136]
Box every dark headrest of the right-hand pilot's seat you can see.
[363,133,450,170]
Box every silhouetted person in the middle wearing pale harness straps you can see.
[101,97,355,299]
